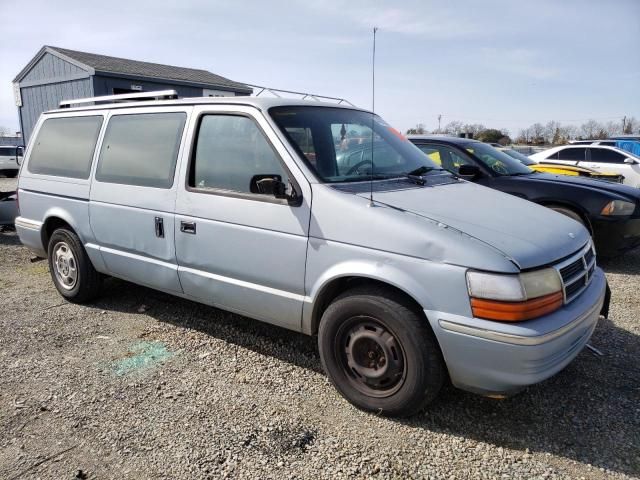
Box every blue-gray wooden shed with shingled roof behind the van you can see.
[13,46,252,143]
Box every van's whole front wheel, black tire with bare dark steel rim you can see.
[318,287,447,416]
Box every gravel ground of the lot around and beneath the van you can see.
[0,173,640,479]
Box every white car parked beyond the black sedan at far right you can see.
[529,145,640,187]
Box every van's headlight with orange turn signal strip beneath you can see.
[467,268,564,322]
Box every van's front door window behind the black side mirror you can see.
[189,115,288,195]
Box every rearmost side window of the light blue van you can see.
[27,116,103,179]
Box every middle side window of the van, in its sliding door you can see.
[96,112,187,188]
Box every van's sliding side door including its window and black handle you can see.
[89,107,192,293]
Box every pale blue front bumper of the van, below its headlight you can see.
[425,268,606,395]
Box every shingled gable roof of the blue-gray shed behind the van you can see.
[14,45,252,94]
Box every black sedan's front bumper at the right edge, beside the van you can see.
[592,218,640,257]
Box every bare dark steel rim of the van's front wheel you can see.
[338,317,406,397]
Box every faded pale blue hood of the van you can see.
[360,182,589,269]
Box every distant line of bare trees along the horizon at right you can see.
[407,117,640,145]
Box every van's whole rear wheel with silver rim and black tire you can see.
[47,228,102,303]
